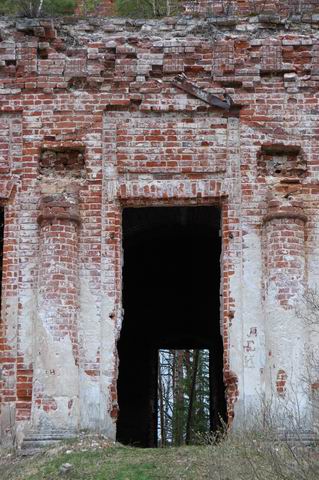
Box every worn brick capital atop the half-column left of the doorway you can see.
[38,192,81,226]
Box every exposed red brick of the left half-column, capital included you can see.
[38,193,80,363]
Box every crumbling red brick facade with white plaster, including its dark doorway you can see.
[0,2,319,445]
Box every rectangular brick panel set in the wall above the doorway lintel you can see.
[106,112,228,174]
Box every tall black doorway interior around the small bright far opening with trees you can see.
[117,206,226,447]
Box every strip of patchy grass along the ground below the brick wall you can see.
[0,432,319,480]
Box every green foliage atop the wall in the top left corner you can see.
[0,0,76,17]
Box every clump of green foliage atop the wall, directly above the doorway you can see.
[116,0,181,18]
